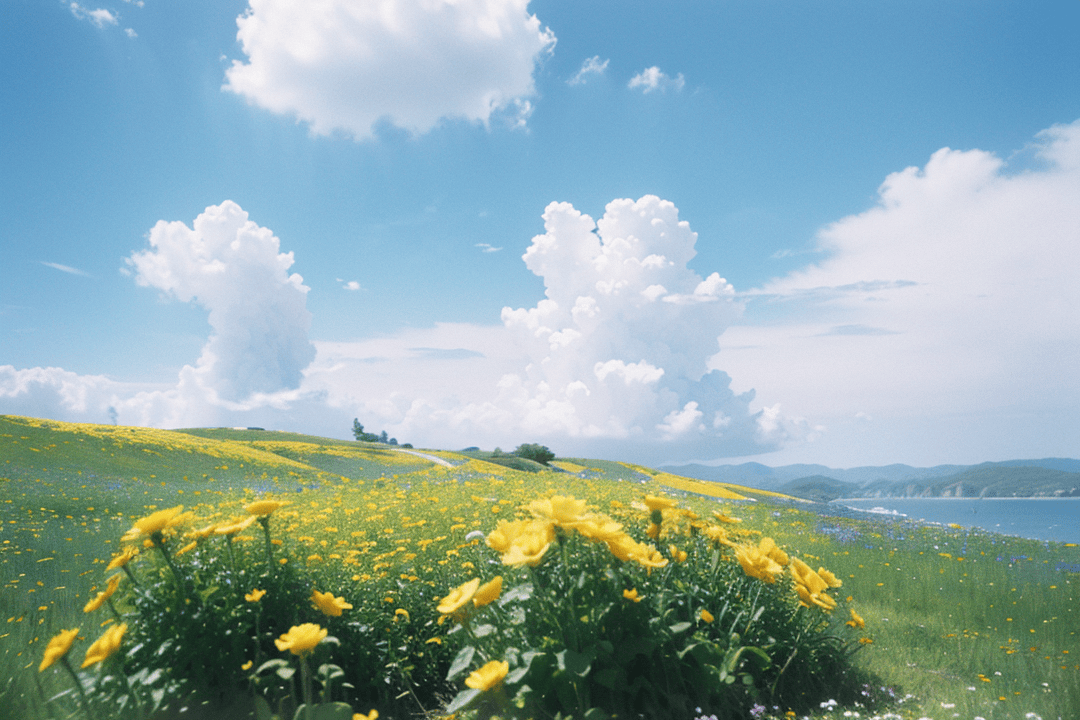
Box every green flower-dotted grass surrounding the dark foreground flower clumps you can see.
[0,417,1080,720]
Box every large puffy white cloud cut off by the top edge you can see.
[225,0,555,139]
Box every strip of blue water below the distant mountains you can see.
[833,498,1080,543]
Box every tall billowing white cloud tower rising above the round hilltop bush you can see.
[500,195,770,452]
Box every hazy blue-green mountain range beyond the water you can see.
[664,458,1080,502]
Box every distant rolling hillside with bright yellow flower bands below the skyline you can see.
[0,416,796,507]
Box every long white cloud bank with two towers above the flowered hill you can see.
[0,195,792,460]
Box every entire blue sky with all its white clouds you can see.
[0,0,1080,467]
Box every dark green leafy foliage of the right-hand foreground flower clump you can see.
[434,511,863,719]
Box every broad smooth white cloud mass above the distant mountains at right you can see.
[719,121,1080,462]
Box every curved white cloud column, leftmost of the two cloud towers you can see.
[127,201,315,403]
